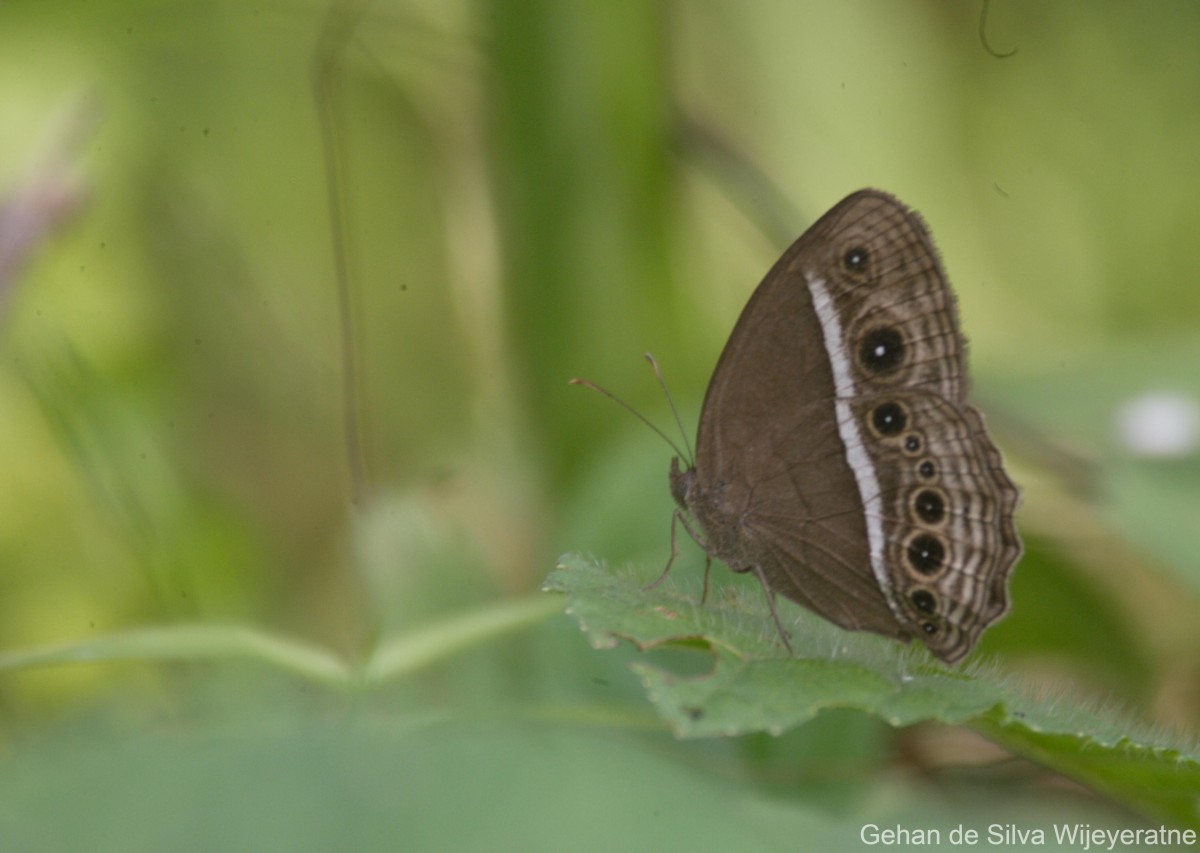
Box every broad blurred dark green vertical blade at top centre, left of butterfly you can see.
[482,0,678,494]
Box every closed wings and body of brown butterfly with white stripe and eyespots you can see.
[671,191,1021,661]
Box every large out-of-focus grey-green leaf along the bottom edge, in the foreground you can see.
[0,697,1171,853]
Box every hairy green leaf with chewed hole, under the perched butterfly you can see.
[545,555,1200,827]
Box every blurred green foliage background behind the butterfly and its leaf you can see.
[0,0,1200,849]
